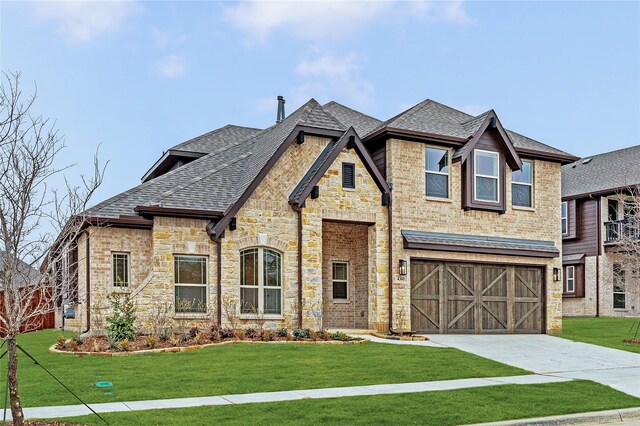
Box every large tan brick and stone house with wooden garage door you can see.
[57,99,576,333]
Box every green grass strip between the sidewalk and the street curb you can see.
[61,381,640,426]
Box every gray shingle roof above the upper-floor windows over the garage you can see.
[368,99,571,160]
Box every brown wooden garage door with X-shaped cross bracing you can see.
[411,260,544,333]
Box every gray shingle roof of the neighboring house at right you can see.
[562,145,640,197]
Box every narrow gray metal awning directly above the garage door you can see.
[402,229,560,258]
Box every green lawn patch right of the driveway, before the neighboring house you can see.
[558,317,640,353]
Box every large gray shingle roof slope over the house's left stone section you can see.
[85,99,342,218]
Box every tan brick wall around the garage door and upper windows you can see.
[386,139,562,333]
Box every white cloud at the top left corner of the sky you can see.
[32,1,139,43]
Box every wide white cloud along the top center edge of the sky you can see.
[225,0,472,42]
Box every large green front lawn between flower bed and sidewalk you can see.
[0,330,528,407]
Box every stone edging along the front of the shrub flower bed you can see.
[49,339,369,357]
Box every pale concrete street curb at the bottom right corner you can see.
[471,407,640,426]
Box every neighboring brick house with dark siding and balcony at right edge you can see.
[561,145,640,316]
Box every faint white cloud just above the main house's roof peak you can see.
[293,53,375,107]
